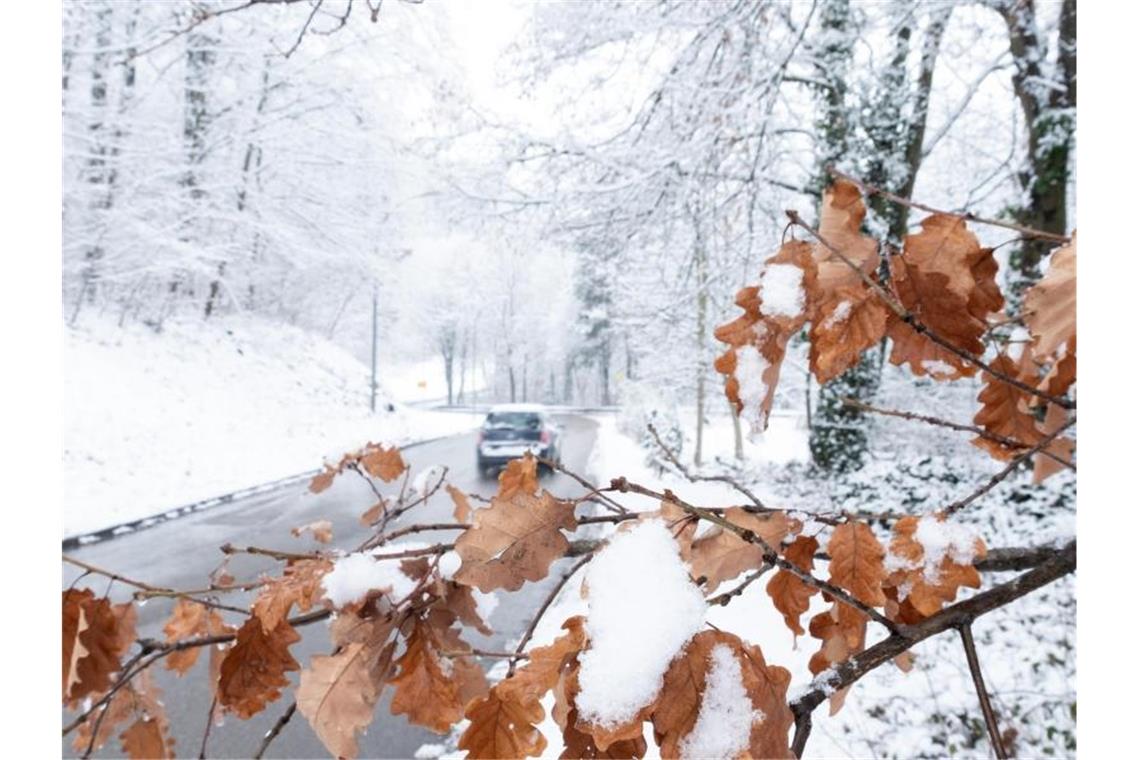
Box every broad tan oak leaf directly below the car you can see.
[455,489,578,593]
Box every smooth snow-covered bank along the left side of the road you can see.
[64,317,479,536]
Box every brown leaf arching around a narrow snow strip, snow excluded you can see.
[653,630,795,758]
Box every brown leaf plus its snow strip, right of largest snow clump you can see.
[653,630,792,759]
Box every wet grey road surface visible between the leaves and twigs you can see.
[63,416,596,758]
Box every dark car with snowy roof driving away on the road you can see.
[475,403,562,475]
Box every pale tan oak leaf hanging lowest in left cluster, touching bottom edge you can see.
[296,643,382,758]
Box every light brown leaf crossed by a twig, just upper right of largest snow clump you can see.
[685,507,801,594]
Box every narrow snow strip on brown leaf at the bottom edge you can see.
[679,644,765,759]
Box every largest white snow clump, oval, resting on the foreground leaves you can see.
[577,520,706,726]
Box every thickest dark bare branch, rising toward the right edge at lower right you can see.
[789,541,1076,757]
